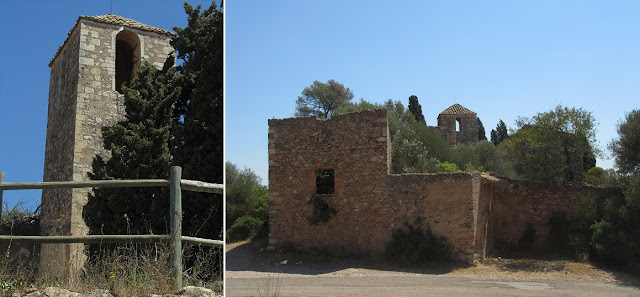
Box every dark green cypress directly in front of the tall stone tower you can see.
[83,57,181,234]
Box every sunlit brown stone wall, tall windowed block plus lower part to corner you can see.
[269,110,484,259]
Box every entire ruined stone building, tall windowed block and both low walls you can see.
[269,110,610,261]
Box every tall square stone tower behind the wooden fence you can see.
[40,14,174,277]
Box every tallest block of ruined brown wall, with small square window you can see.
[269,110,389,251]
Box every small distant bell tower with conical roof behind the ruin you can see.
[438,103,478,145]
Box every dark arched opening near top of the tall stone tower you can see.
[116,31,140,93]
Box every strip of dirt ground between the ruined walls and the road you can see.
[226,241,640,286]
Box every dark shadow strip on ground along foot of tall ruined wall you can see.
[226,238,466,275]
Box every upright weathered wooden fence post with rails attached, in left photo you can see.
[169,166,182,289]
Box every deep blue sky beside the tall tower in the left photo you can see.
[0,0,211,209]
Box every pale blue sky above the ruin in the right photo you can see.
[225,0,640,184]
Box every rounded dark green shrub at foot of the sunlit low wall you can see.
[384,222,451,265]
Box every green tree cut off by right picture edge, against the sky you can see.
[609,109,640,174]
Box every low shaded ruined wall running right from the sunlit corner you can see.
[491,179,621,251]
